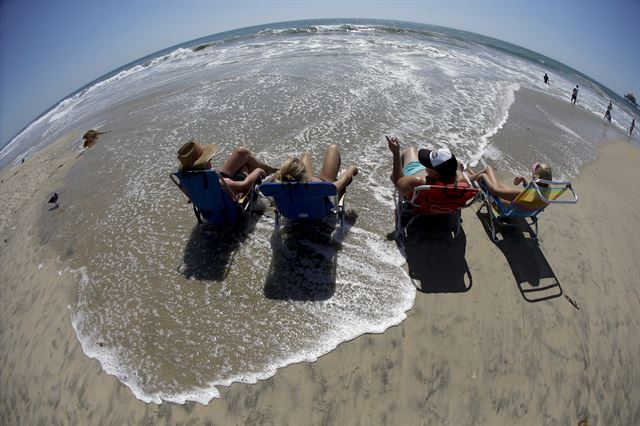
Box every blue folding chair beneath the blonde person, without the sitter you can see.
[259,182,345,230]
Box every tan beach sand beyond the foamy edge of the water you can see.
[0,132,640,425]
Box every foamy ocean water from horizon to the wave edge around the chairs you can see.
[0,20,637,404]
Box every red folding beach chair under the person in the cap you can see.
[396,180,480,238]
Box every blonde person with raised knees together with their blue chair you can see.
[260,144,358,230]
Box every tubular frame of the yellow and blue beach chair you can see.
[478,179,578,243]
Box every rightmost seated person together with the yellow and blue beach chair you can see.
[467,162,578,242]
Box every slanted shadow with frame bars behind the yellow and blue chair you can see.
[476,209,562,303]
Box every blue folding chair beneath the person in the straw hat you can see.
[170,170,257,225]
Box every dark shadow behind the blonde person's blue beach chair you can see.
[264,212,357,301]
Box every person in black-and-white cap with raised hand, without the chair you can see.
[386,136,459,196]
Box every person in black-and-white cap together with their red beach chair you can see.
[387,136,479,237]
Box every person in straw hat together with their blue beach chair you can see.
[171,139,276,225]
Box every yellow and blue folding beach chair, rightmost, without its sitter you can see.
[480,179,578,242]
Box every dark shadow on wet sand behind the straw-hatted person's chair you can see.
[181,208,264,281]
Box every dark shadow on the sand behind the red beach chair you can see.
[395,214,473,293]
